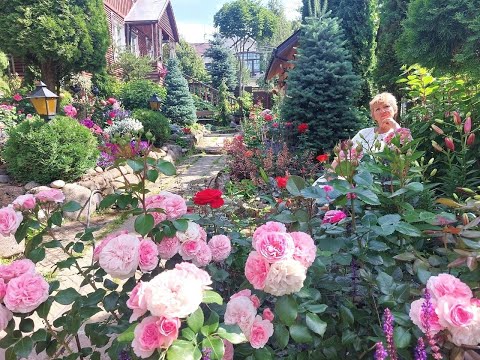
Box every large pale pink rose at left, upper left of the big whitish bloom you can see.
[98,234,140,279]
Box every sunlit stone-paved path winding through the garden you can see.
[0,133,233,360]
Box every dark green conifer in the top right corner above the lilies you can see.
[396,0,480,74]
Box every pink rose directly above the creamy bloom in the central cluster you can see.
[256,232,295,263]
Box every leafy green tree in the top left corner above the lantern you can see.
[0,0,109,90]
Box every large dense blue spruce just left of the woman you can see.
[282,16,360,150]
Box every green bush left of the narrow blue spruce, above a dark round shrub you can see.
[119,80,167,110]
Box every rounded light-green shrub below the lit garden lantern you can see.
[3,116,99,184]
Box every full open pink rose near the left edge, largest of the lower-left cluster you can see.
[3,272,48,314]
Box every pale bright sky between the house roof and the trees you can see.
[171,0,302,43]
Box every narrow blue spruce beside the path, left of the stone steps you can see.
[163,59,197,125]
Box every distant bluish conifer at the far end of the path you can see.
[204,34,238,90]
